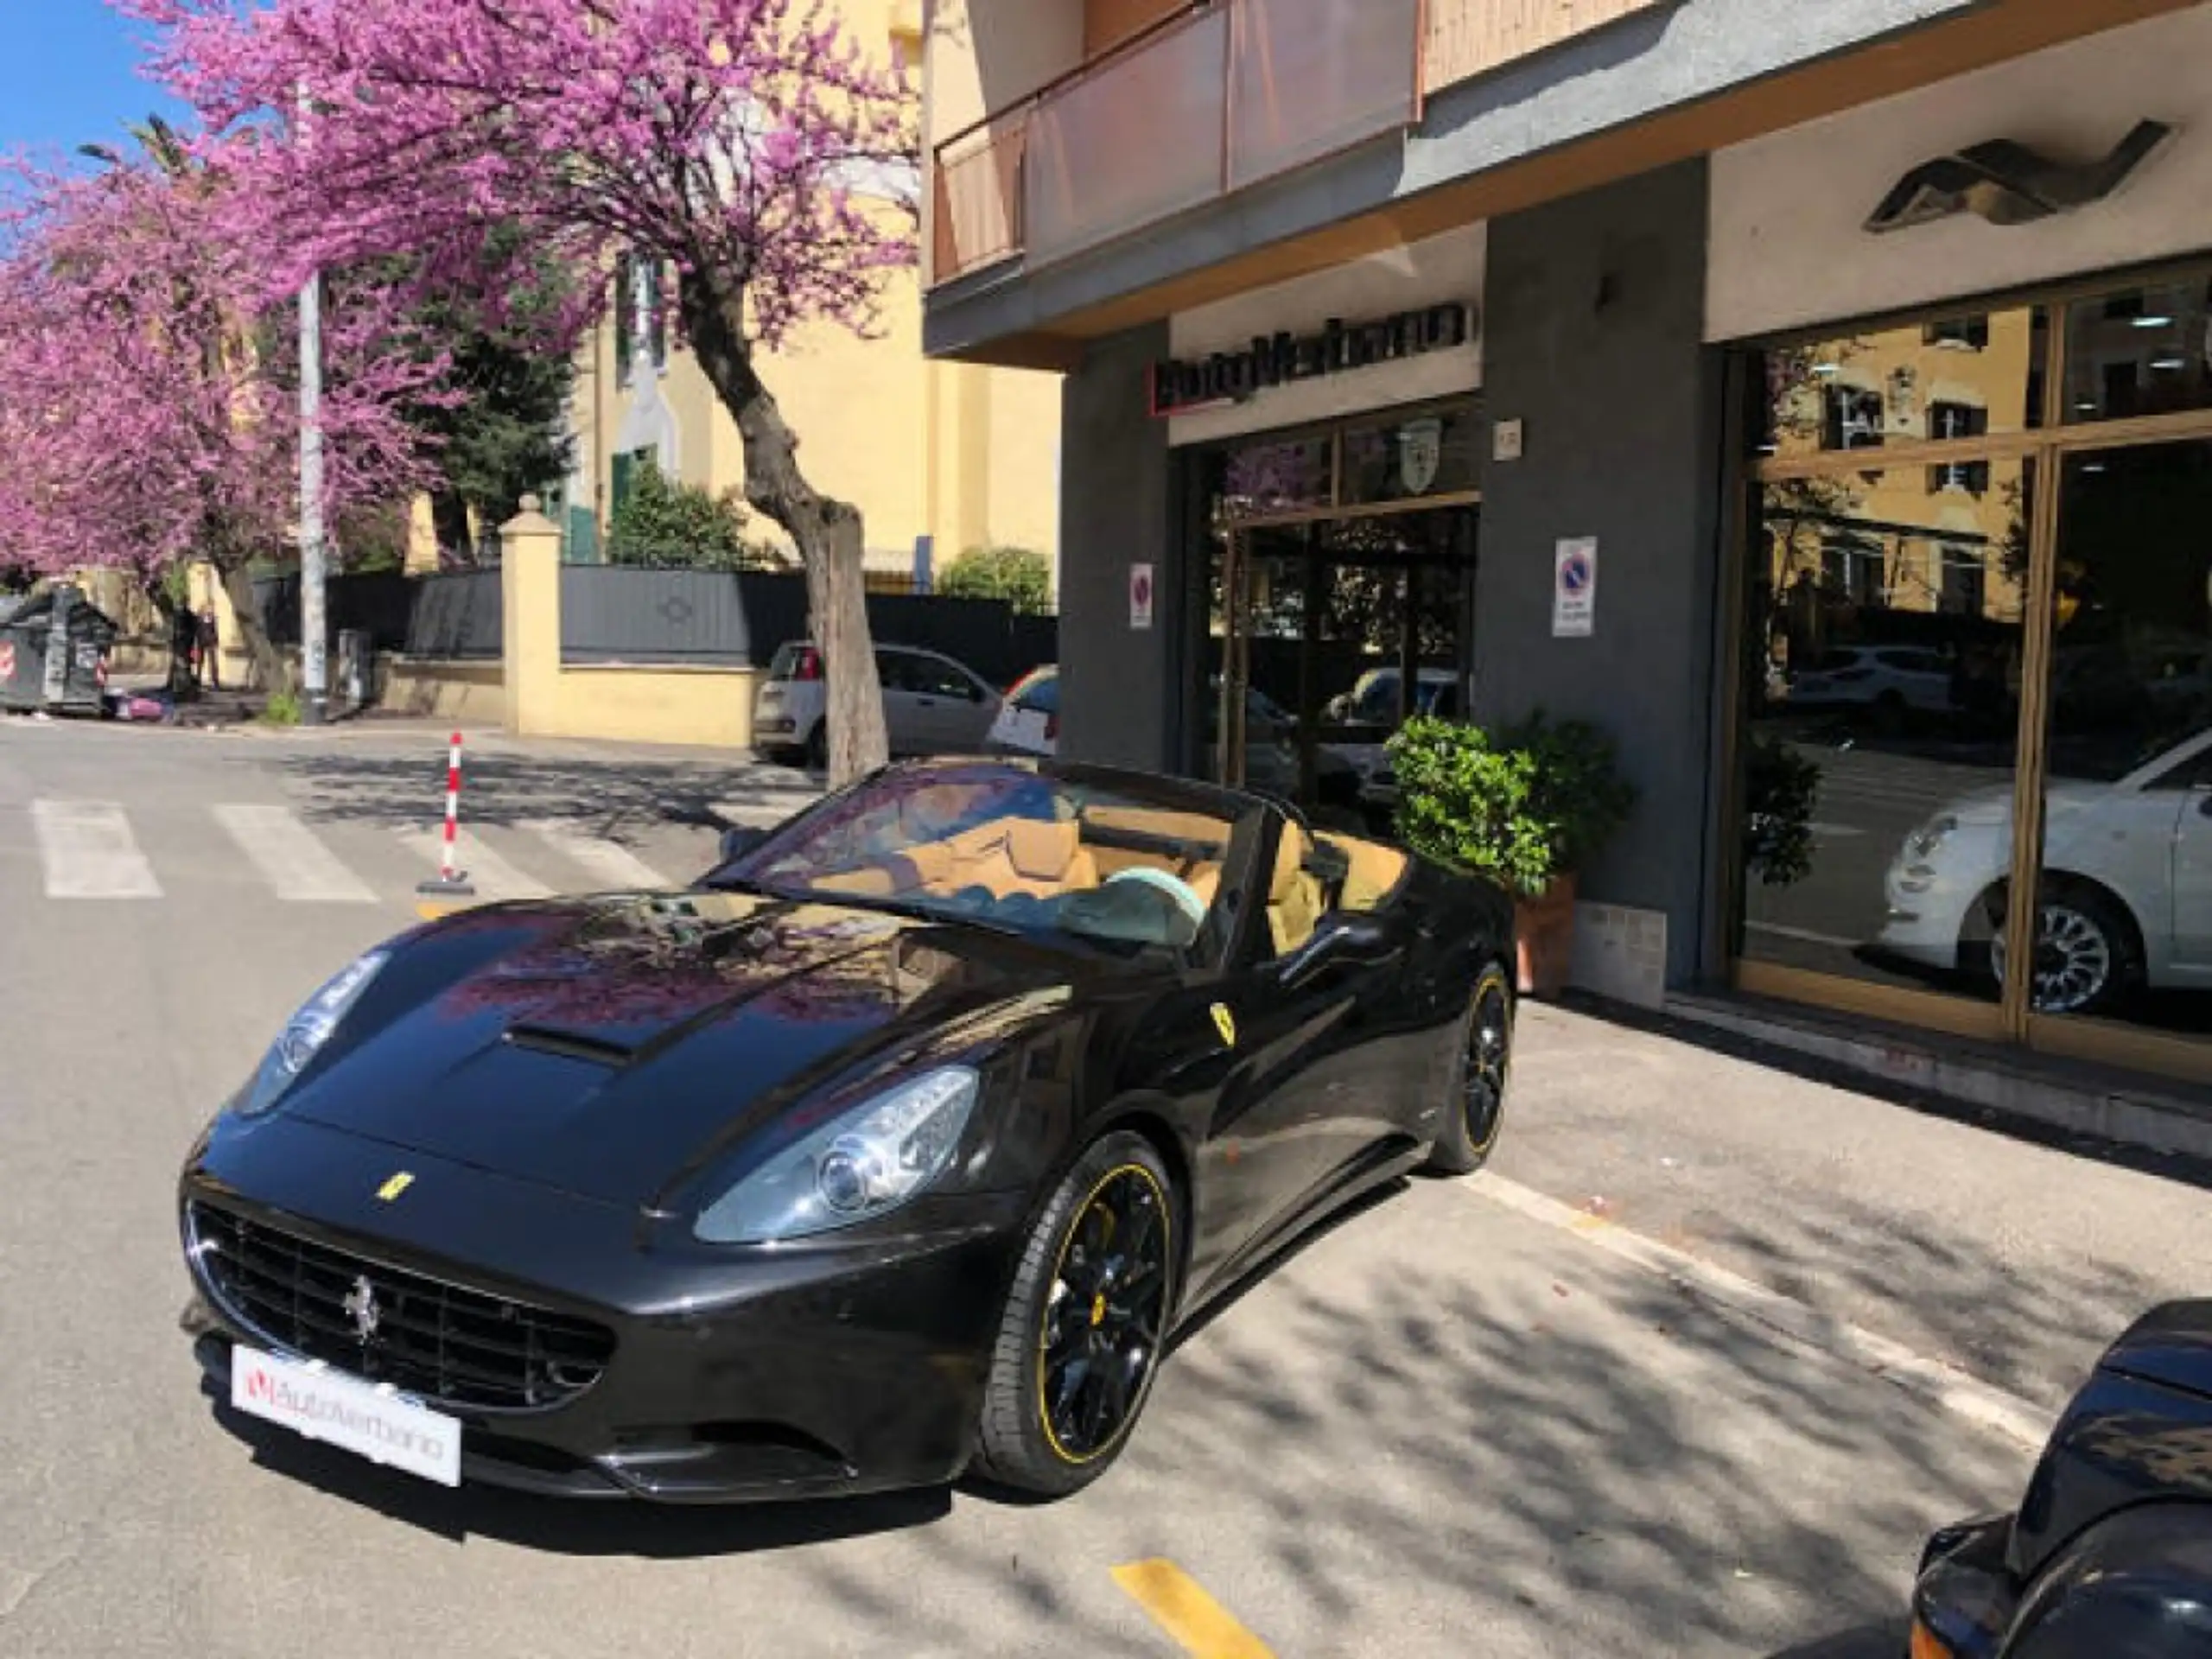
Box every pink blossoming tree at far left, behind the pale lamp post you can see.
[0,145,442,686]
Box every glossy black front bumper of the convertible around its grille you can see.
[181,1123,1022,1504]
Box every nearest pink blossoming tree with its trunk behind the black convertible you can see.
[115,0,918,781]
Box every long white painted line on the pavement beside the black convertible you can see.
[1462,1170,2050,1451]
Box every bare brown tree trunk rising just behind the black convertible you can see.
[681,272,892,787]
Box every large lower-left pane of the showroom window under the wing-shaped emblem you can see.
[1738,458,2033,998]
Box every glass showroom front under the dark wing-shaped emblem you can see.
[1707,11,2212,1079]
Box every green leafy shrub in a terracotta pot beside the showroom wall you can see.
[1391,710,1635,995]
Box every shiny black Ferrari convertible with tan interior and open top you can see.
[179,761,1513,1502]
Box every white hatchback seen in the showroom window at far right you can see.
[1880,730,2212,1013]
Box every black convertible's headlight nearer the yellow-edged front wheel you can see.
[692,1066,980,1243]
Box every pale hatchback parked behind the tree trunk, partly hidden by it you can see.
[752,641,1000,770]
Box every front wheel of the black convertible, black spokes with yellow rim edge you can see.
[976,1130,1184,1497]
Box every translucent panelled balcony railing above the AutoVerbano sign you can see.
[929,0,1425,283]
